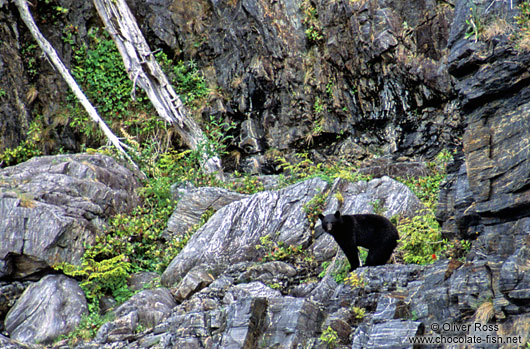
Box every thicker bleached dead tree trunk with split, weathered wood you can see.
[93,0,222,177]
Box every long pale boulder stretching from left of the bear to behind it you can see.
[162,177,422,286]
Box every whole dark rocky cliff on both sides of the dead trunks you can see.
[0,0,461,172]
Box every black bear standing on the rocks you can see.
[318,211,399,271]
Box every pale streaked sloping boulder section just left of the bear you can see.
[162,178,327,286]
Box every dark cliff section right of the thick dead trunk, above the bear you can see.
[135,0,459,167]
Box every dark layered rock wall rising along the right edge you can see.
[438,1,530,332]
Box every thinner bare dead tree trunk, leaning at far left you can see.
[14,0,136,167]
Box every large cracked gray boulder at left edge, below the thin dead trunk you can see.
[0,154,139,278]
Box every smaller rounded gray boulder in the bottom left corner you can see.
[5,275,88,344]
